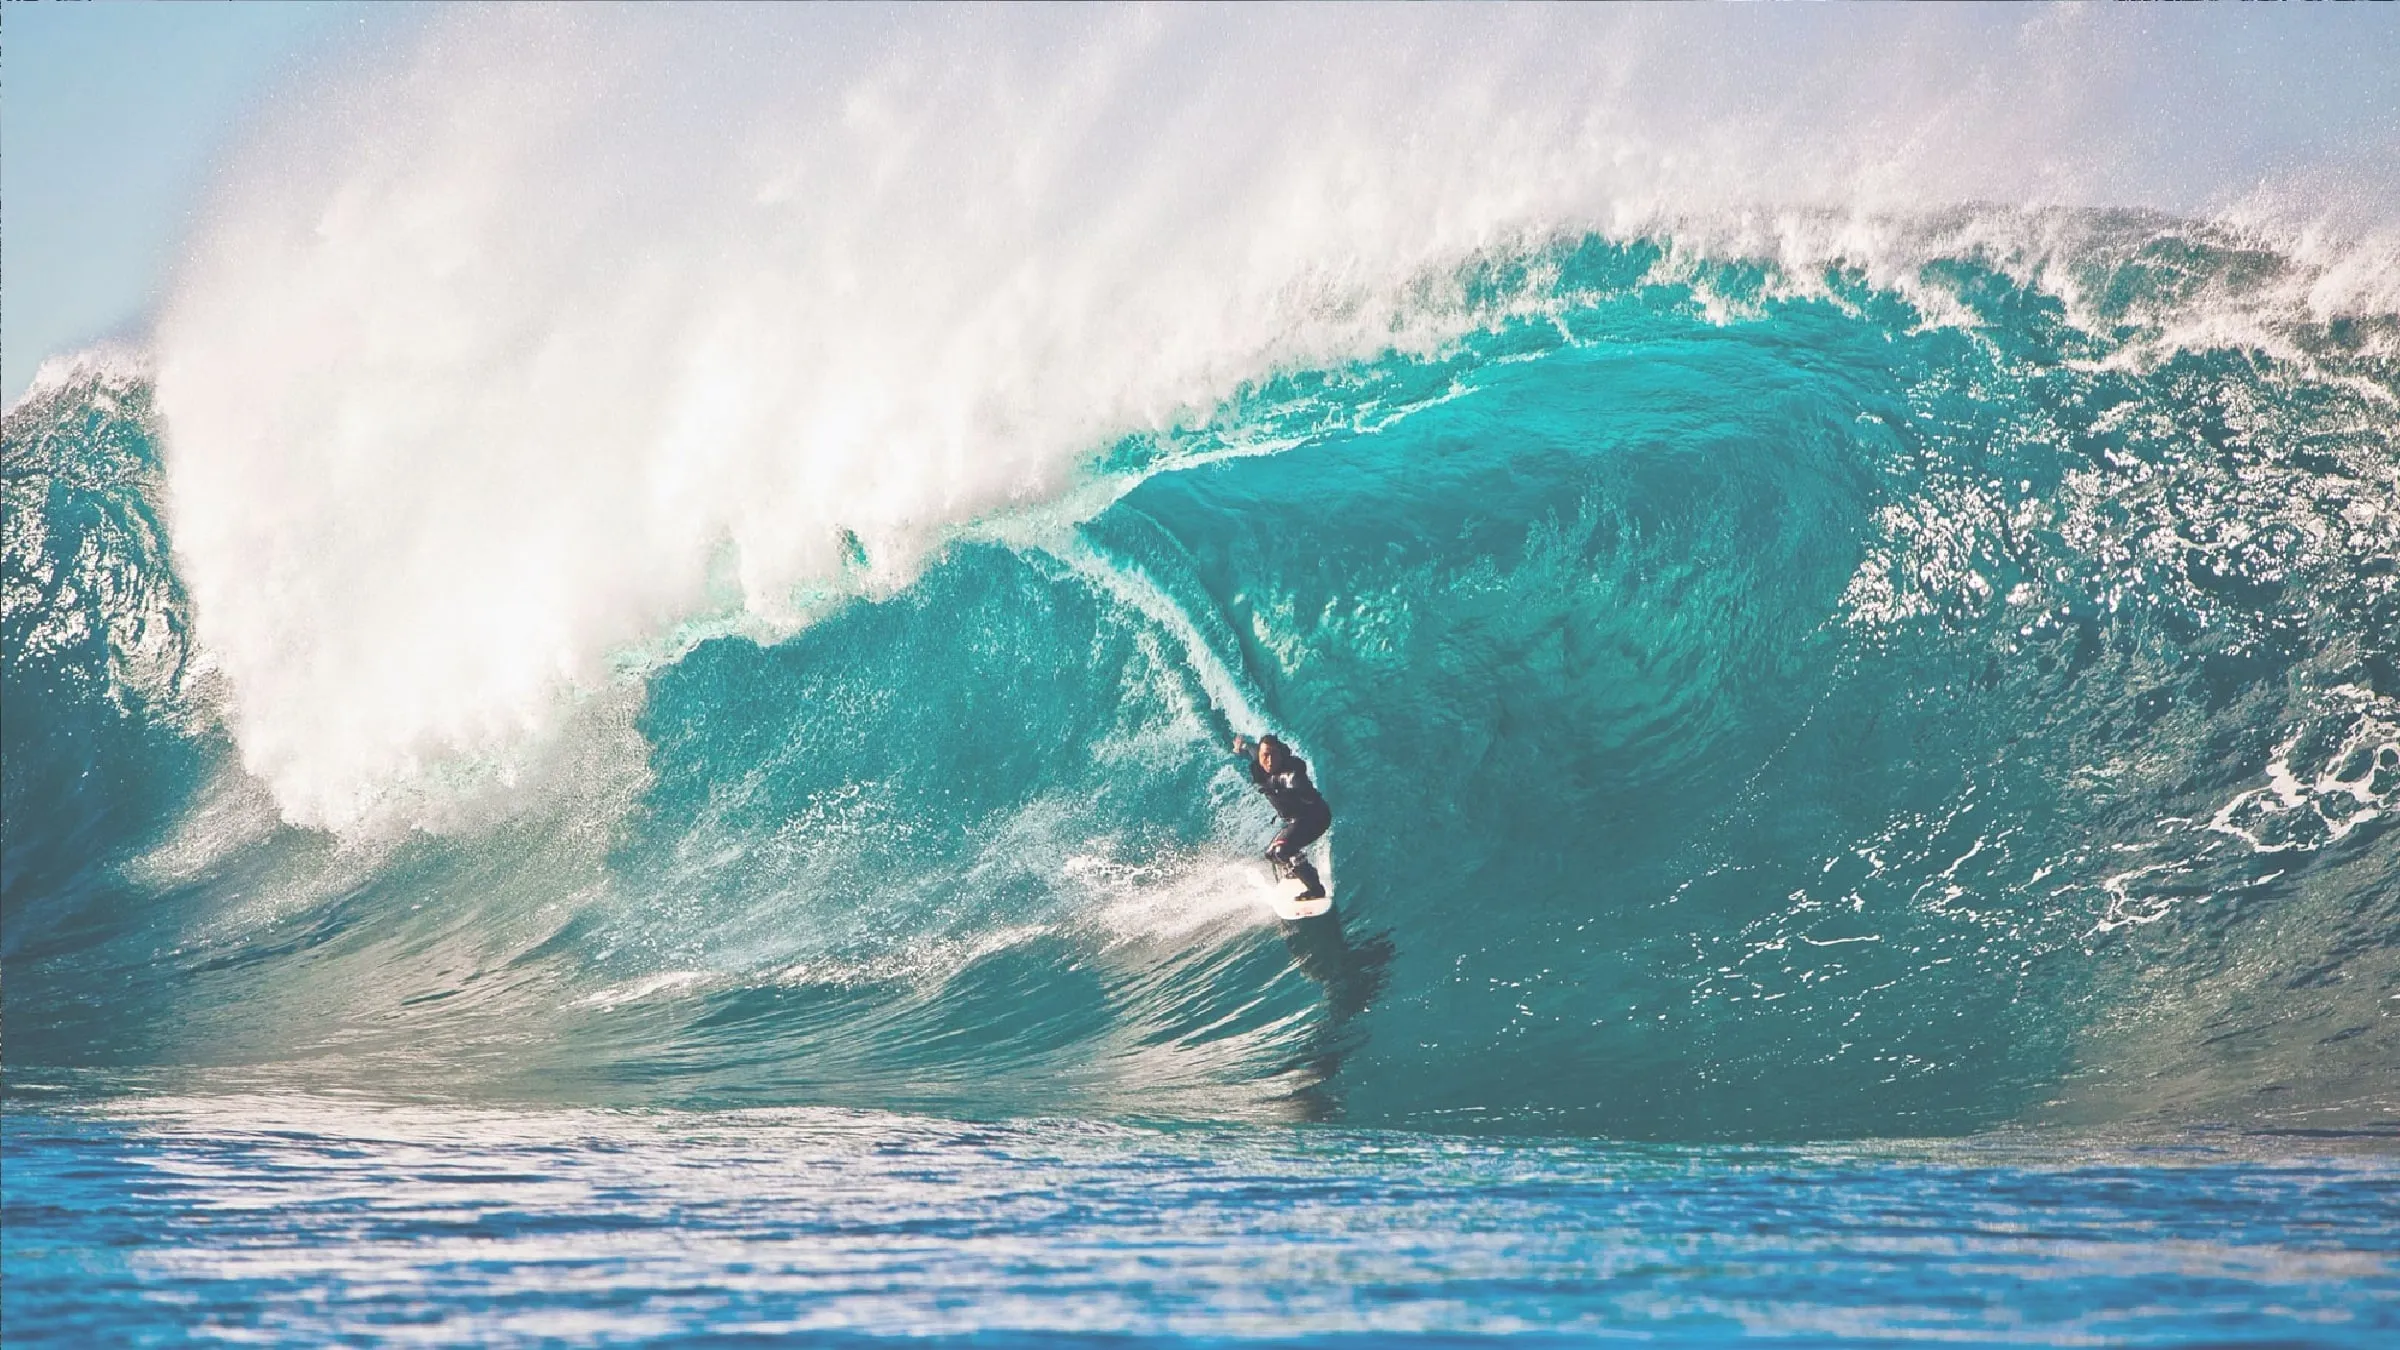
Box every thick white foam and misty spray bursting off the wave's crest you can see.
[156,7,2400,829]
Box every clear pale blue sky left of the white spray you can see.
[0,0,372,399]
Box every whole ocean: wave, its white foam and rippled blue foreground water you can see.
[0,14,2400,1345]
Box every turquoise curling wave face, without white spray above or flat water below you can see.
[7,226,2400,1136]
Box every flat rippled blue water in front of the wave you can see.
[5,1095,2400,1348]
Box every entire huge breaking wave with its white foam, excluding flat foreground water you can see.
[0,14,2400,1139]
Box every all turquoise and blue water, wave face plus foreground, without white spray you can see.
[5,216,2400,1345]
